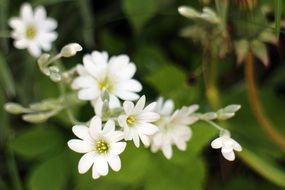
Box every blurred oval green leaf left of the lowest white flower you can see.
[10,126,65,159]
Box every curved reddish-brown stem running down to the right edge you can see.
[245,53,285,149]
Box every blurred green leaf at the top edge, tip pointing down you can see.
[123,0,159,32]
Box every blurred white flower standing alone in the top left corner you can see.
[9,3,57,57]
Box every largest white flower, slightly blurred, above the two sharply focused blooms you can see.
[72,51,142,105]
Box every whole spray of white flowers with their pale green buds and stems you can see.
[5,1,242,179]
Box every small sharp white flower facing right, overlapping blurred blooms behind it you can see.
[118,96,160,147]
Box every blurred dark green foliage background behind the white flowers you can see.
[0,0,285,190]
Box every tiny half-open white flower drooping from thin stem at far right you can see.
[211,131,242,161]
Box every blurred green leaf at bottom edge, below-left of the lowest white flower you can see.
[28,152,69,190]
